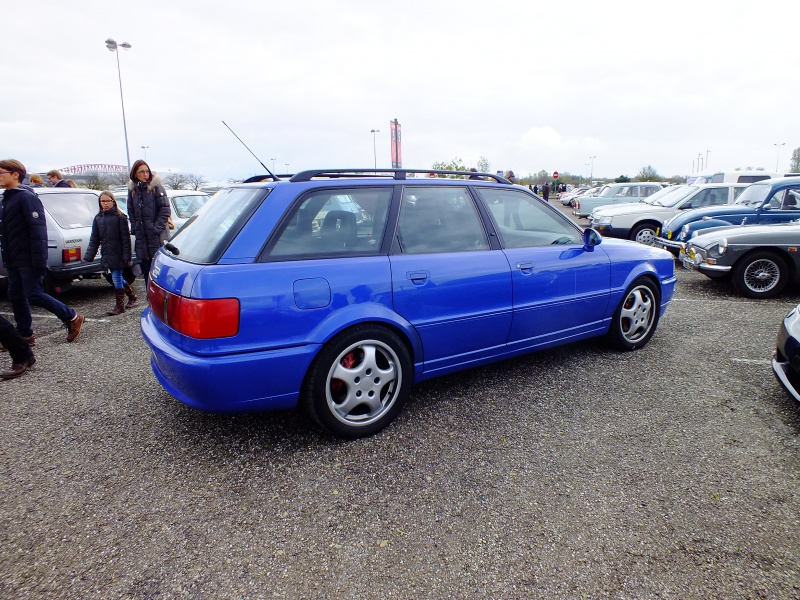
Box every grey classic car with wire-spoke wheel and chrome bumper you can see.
[679,220,800,298]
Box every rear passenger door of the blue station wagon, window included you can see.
[390,186,512,373]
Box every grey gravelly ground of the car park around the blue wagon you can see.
[0,268,800,599]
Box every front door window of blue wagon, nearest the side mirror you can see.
[478,188,583,248]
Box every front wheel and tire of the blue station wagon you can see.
[608,277,661,350]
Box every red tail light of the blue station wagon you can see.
[147,280,239,339]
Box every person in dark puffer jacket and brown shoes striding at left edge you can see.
[0,159,84,346]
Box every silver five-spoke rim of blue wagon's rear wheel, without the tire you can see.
[325,340,403,427]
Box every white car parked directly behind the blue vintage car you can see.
[589,183,748,246]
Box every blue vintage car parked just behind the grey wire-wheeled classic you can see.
[656,177,800,255]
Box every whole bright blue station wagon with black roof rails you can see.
[141,169,675,438]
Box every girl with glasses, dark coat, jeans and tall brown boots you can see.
[84,192,137,315]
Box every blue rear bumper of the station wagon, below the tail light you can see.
[141,308,319,413]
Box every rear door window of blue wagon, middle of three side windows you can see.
[397,186,489,254]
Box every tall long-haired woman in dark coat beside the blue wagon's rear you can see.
[128,159,170,286]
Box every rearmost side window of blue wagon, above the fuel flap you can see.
[269,186,392,258]
